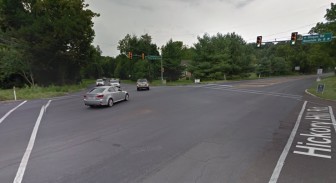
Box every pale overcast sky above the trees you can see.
[85,0,334,56]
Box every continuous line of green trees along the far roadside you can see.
[0,0,336,88]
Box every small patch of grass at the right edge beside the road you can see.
[308,76,336,100]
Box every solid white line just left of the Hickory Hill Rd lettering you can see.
[269,101,307,183]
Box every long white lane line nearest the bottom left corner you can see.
[14,100,51,183]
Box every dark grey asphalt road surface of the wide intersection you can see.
[0,77,336,183]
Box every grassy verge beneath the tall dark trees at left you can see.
[0,80,95,101]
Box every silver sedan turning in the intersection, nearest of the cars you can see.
[84,86,129,107]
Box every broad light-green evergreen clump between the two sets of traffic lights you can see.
[188,33,253,80]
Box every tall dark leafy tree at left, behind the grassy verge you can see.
[0,0,99,85]
